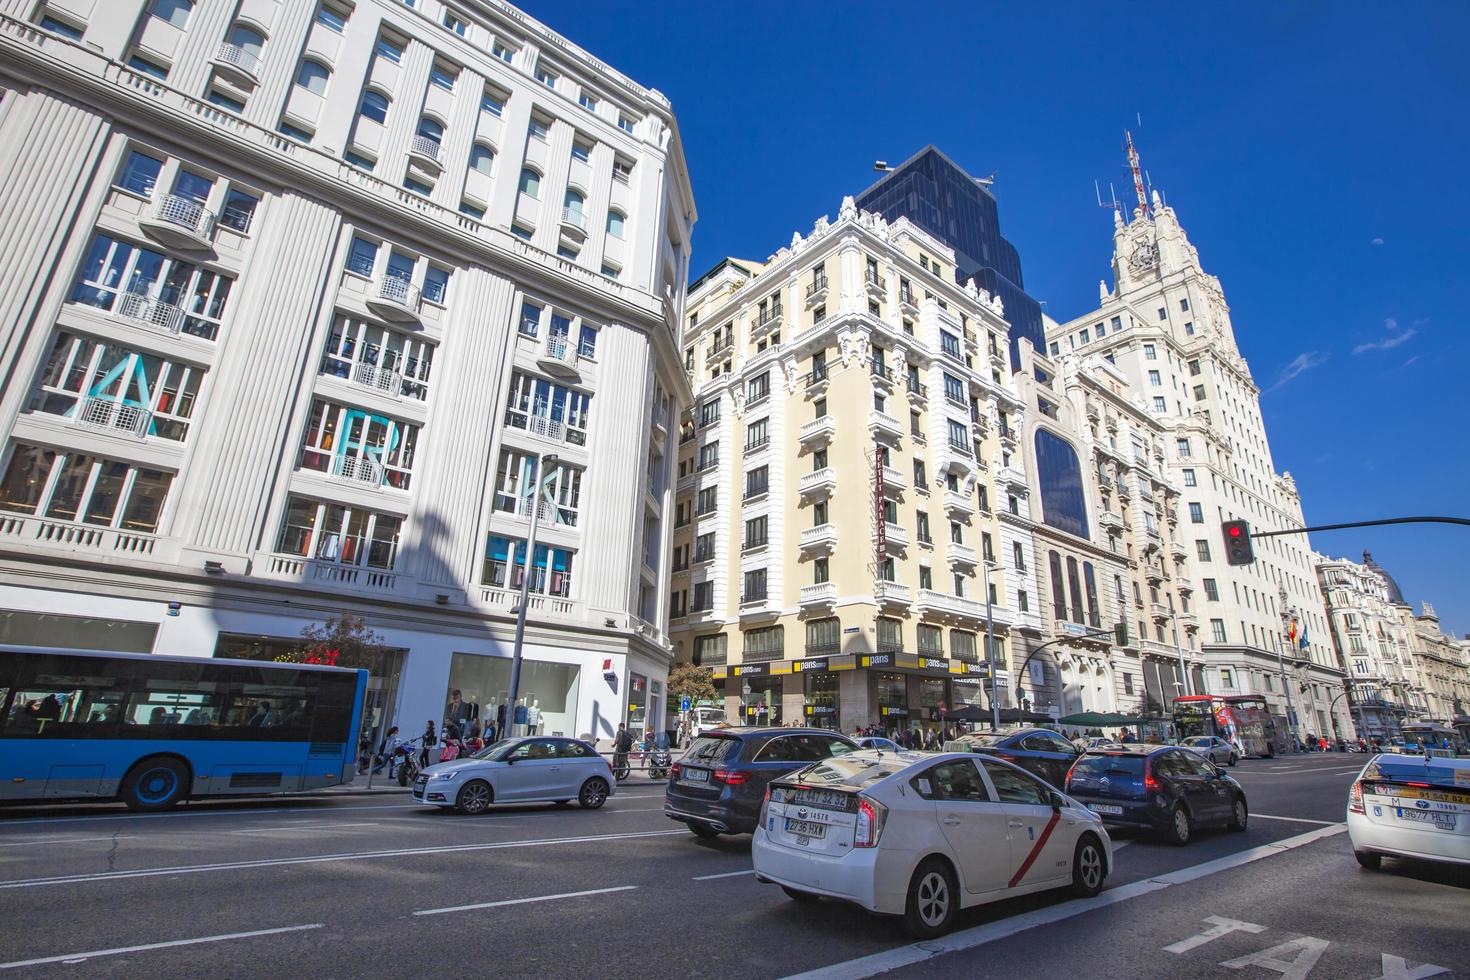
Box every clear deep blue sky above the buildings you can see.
[520,0,1470,633]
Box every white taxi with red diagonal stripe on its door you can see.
[751,751,1113,939]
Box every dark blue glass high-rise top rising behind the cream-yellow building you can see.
[857,145,1047,367]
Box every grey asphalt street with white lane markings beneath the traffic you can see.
[0,755,1470,980]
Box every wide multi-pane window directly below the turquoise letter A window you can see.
[0,442,173,533]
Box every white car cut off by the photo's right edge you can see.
[1348,755,1470,868]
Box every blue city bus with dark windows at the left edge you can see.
[0,646,368,811]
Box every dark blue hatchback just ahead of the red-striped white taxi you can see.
[1066,745,1250,846]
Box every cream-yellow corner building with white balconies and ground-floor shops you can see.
[670,198,1023,732]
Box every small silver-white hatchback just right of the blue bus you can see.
[413,738,617,814]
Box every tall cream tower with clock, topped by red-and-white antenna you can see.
[1047,182,1347,736]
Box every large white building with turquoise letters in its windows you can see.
[0,0,695,735]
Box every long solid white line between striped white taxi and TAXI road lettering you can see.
[786,824,1348,980]
